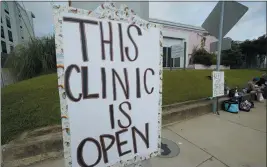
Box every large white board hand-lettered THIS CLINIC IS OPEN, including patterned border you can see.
[54,3,162,167]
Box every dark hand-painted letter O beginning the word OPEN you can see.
[77,137,102,167]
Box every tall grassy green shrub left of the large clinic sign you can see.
[5,36,56,80]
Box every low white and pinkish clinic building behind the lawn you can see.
[149,19,217,68]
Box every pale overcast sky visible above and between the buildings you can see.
[20,2,266,41]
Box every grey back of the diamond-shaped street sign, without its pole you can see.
[202,1,248,39]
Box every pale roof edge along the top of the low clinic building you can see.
[149,18,207,32]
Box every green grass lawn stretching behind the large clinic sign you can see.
[2,70,263,143]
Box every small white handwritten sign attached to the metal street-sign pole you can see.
[212,71,224,97]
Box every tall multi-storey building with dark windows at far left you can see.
[0,1,35,54]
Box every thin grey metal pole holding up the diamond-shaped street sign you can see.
[212,1,224,115]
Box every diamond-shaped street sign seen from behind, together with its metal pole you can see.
[202,1,248,114]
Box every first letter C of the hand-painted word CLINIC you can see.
[64,64,82,102]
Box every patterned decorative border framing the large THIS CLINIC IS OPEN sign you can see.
[53,3,163,167]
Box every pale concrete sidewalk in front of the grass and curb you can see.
[30,103,266,167]
